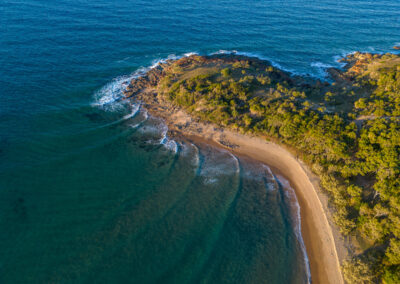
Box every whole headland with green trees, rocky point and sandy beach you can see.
[125,53,400,283]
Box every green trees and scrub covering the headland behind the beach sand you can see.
[128,53,400,283]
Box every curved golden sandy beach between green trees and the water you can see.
[141,96,346,284]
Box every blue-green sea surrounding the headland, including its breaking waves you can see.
[0,0,400,283]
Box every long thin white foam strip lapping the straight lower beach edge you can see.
[277,175,311,284]
